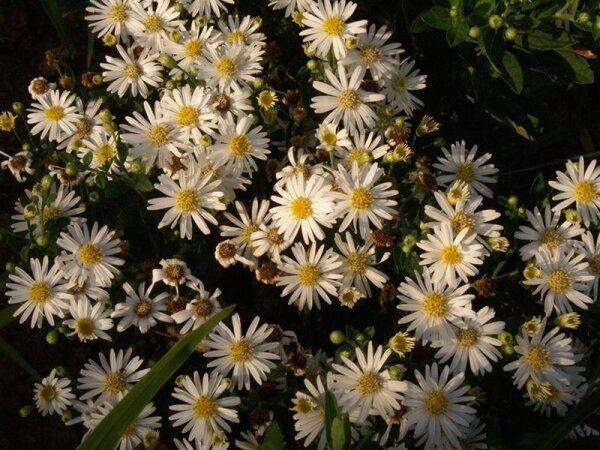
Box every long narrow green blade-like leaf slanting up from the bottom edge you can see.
[78,305,235,450]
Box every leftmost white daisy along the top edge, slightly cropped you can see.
[85,0,135,42]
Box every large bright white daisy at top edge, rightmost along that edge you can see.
[300,0,367,59]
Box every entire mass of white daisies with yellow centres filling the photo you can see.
[2,0,600,450]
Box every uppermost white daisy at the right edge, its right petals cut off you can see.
[548,156,600,227]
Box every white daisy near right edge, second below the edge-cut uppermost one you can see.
[523,248,594,316]
